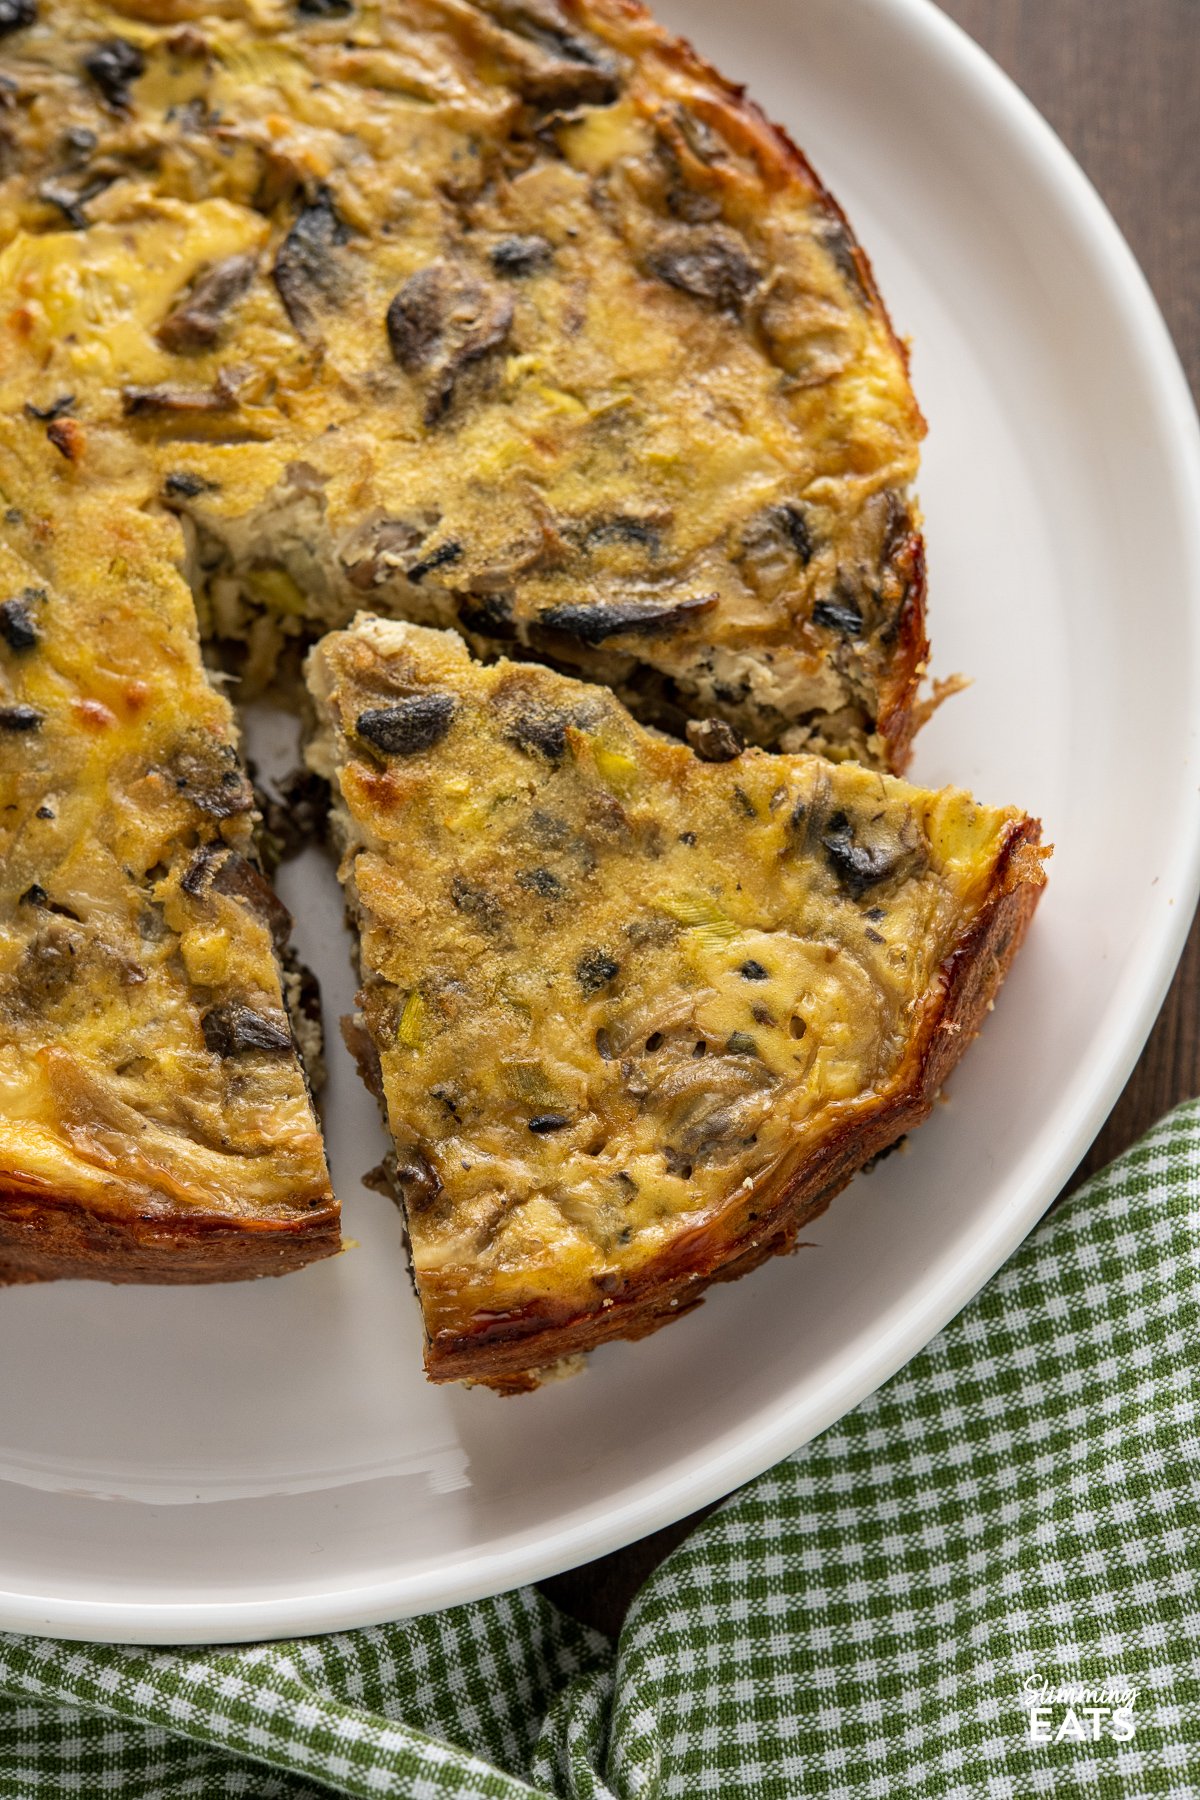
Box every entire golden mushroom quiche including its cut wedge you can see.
[0,0,1040,1360]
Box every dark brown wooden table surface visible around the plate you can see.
[542,0,1200,1633]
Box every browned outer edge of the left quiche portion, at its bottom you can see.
[0,1188,342,1285]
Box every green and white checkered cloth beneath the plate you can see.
[0,1103,1200,1800]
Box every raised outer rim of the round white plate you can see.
[9,0,1200,1643]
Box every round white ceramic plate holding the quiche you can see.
[0,0,1200,1642]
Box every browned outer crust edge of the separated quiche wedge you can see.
[425,819,1043,1393]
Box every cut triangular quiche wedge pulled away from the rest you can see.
[308,616,1043,1391]
